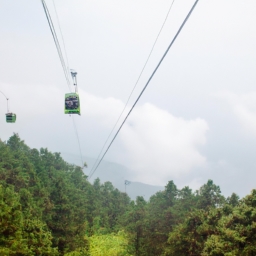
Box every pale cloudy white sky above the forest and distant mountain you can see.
[0,0,256,196]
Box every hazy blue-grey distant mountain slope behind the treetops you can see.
[61,153,164,200]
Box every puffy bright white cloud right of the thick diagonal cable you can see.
[115,103,208,185]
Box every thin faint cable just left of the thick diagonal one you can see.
[91,0,175,178]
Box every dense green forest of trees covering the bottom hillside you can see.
[0,134,256,256]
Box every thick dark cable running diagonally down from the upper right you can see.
[88,0,199,179]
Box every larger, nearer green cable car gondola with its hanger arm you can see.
[64,69,80,115]
